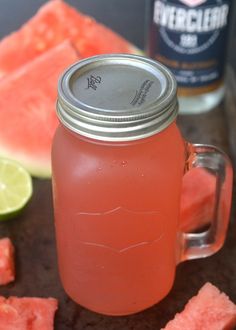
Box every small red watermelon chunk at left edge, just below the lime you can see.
[0,238,15,285]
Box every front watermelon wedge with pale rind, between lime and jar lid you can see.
[0,41,78,177]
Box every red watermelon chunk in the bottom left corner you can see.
[0,297,58,330]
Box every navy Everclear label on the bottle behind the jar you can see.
[151,0,230,94]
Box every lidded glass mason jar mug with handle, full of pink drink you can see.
[52,55,232,315]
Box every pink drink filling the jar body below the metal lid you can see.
[53,124,184,315]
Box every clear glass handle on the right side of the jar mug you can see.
[179,143,233,262]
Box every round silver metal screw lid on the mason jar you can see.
[57,54,178,141]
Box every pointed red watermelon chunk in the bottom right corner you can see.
[163,283,236,330]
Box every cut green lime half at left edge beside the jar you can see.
[0,158,32,220]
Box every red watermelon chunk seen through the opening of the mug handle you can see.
[180,168,216,232]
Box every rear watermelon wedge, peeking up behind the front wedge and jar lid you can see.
[0,0,140,78]
